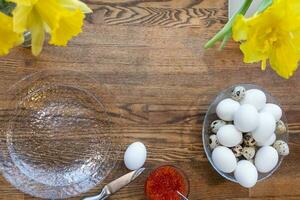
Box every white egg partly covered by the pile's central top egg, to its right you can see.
[252,112,276,143]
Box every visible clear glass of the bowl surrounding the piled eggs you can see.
[202,84,289,182]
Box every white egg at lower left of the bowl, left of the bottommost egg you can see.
[212,146,237,173]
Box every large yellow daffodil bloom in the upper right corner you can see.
[232,0,300,78]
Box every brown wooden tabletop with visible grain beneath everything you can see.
[0,0,300,200]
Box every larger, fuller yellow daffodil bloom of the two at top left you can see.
[10,0,92,55]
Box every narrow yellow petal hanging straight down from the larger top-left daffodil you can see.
[28,11,45,56]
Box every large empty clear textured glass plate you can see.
[0,71,119,199]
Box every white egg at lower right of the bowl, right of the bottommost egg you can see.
[254,146,278,173]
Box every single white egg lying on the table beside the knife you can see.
[124,142,147,170]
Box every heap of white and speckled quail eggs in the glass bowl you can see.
[209,86,289,188]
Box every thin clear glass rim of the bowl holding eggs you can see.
[202,83,289,183]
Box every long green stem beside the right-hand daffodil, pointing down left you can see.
[204,0,253,49]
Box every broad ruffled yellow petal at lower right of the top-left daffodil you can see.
[49,9,84,46]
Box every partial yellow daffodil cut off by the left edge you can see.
[0,12,23,56]
